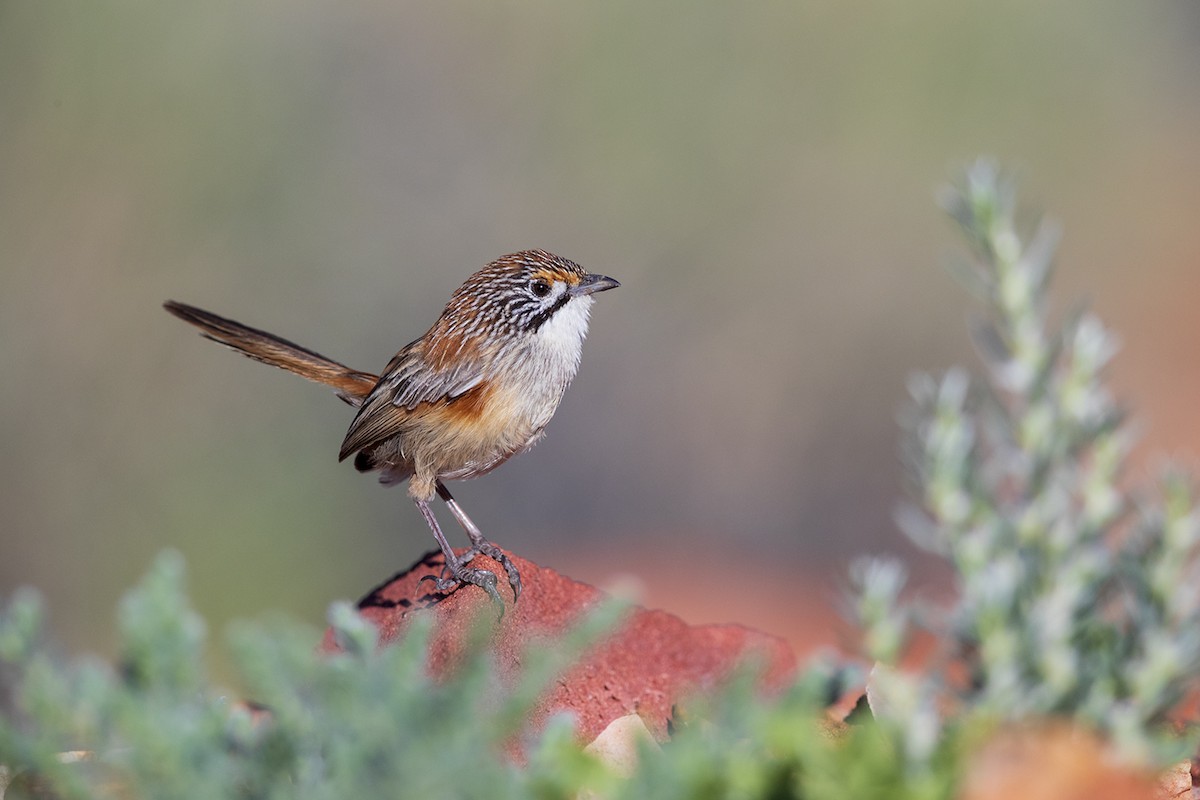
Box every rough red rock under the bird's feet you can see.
[323,553,796,741]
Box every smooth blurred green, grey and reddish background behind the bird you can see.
[0,0,1200,676]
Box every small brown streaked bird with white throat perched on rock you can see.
[163,249,620,613]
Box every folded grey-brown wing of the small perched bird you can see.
[338,342,485,461]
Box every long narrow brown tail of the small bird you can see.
[162,300,379,407]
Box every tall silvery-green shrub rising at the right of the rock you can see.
[853,161,1200,758]
